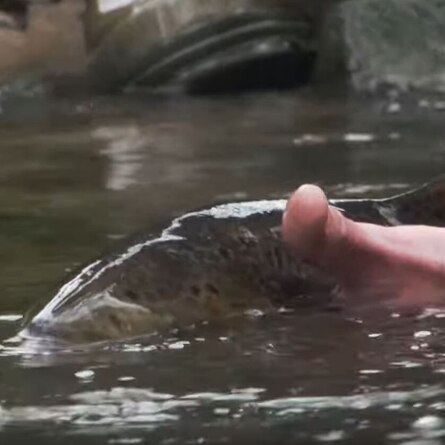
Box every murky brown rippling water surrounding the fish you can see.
[0,89,445,445]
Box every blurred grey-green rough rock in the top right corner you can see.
[317,0,445,92]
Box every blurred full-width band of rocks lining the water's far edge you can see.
[0,0,445,93]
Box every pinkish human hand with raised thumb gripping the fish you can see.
[283,185,445,306]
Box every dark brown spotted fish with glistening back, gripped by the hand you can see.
[15,177,445,343]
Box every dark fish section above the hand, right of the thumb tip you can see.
[332,176,445,227]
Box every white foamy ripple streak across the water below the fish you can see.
[0,387,445,436]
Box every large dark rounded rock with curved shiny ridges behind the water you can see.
[87,0,324,92]
